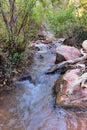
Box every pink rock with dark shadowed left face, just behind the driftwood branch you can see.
[55,45,81,64]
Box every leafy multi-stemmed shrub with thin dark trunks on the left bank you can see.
[0,0,39,77]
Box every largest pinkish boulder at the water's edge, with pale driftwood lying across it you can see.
[54,69,87,108]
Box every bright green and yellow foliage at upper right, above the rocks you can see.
[46,0,87,37]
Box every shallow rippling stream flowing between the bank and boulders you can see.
[0,43,87,130]
